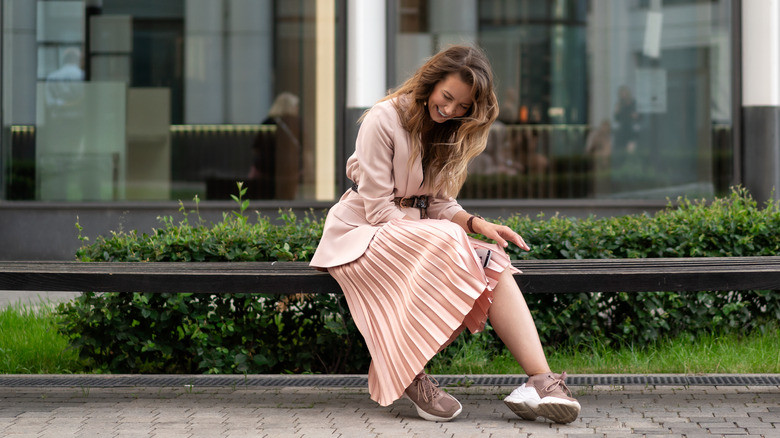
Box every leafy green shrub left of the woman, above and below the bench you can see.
[59,185,369,373]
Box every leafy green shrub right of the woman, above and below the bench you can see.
[496,188,780,350]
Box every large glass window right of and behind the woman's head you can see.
[395,0,732,199]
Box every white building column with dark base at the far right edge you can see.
[741,0,780,203]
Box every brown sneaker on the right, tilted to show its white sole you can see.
[504,372,581,424]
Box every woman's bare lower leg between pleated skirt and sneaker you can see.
[488,269,550,376]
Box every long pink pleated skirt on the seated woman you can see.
[328,219,519,406]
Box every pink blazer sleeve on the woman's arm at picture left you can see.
[355,105,404,225]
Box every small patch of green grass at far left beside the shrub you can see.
[0,301,81,374]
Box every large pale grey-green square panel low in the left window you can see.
[35,81,126,201]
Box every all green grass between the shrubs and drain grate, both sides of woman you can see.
[0,301,780,374]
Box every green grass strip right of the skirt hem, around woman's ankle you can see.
[428,326,780,374]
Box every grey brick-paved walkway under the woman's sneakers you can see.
[0,378,780,438]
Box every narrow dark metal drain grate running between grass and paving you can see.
[0,374,780,388]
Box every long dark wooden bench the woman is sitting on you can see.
[0,256,780,294]
